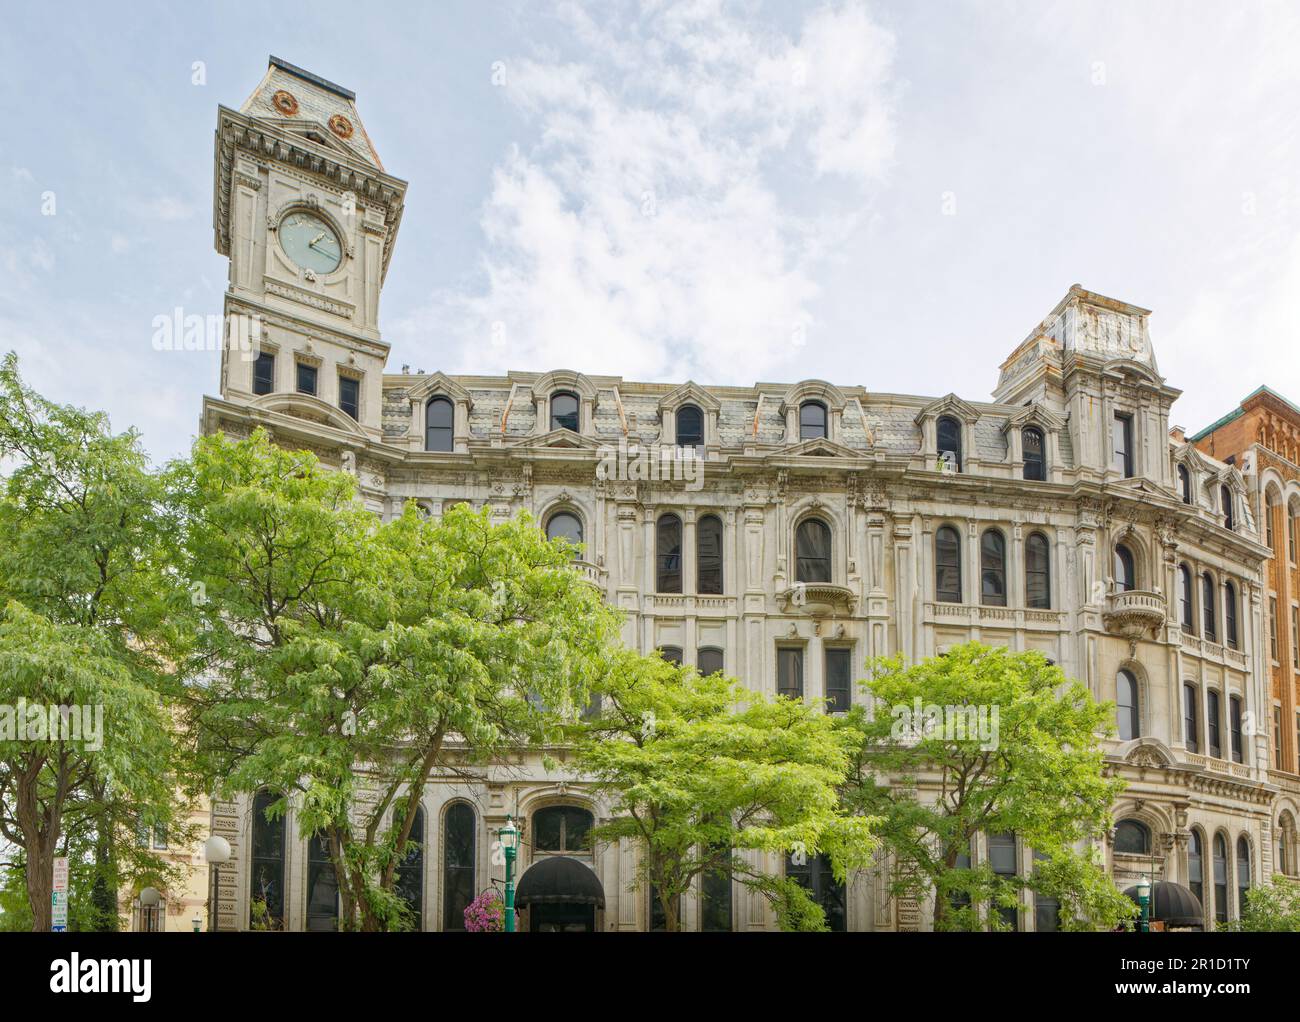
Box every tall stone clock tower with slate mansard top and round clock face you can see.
[203,57,407,444]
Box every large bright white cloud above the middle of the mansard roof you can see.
[394,0,893,381]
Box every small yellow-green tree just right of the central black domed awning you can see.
[575,649,875,931]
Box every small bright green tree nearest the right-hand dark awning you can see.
[841,642,1132,930]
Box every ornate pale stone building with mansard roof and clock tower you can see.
[202,59,1279,930]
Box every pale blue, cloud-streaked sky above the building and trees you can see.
[0,0,1300,460]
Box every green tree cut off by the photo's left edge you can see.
[0,354,189,930]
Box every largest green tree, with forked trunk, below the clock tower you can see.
[172,432,618,930]
